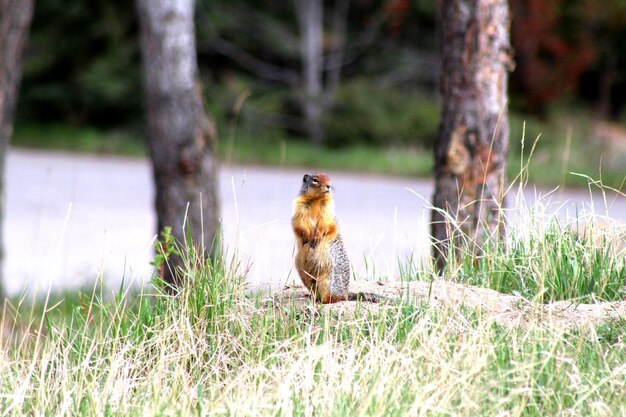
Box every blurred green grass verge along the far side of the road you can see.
[12,98,626,189]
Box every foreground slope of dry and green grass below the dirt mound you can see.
[0,278,626,416]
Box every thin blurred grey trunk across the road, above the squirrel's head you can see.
[296,0,324,146]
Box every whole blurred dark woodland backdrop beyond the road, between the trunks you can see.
[15,0,626,185]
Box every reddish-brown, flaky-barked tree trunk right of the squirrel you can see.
[431,0,512,271]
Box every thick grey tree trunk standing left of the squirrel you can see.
[137,0,220,286]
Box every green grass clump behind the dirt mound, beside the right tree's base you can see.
[449,221,626,303]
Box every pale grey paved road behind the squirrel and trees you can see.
[5,150,626,293]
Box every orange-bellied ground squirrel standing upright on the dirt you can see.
[291,172,381,304]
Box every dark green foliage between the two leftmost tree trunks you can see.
[17,0,142,128]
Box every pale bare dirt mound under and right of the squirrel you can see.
[273,280,626,328]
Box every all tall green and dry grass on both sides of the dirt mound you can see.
[0,203,626,416]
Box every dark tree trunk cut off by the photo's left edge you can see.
[0,0,34,300]
